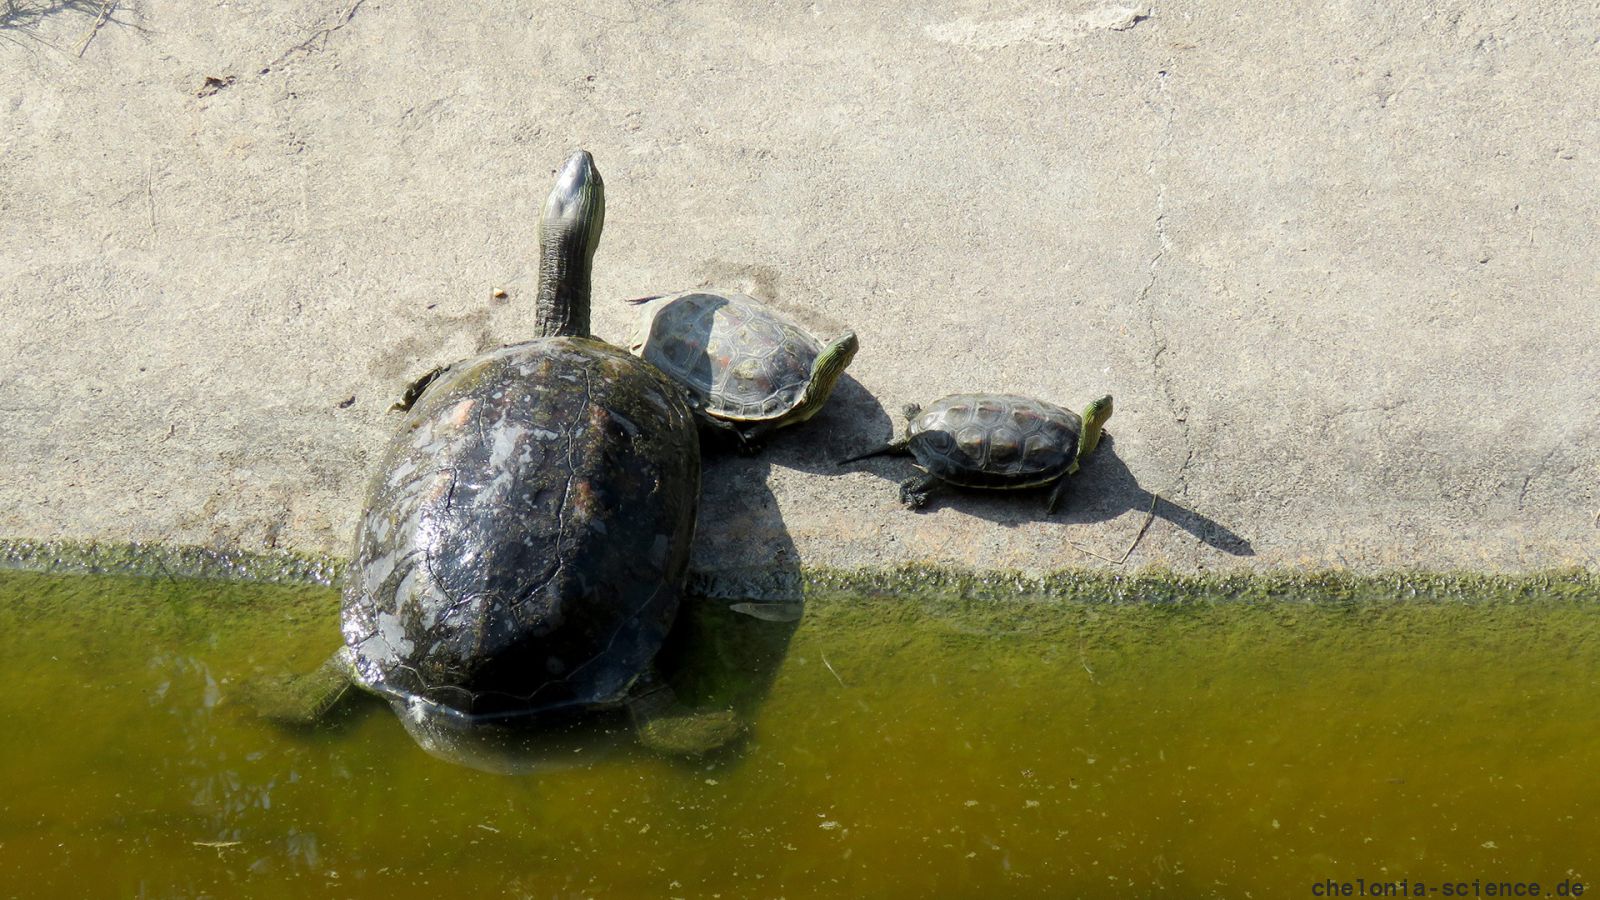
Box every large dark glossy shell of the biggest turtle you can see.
[342,338,699,717]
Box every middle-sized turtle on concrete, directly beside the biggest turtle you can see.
[629,290,859,445]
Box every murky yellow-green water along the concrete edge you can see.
[0,573,1600,898]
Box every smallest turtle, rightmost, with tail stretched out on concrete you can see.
[838,394,1112,512]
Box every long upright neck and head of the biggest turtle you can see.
[534,151,605,338]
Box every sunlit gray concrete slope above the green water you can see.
[0,0,1600,572]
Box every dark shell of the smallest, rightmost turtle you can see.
[910,394,1083,487]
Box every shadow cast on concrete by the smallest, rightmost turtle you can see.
[846,434,1256,556]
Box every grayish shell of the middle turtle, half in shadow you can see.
[640,291,822,421]
